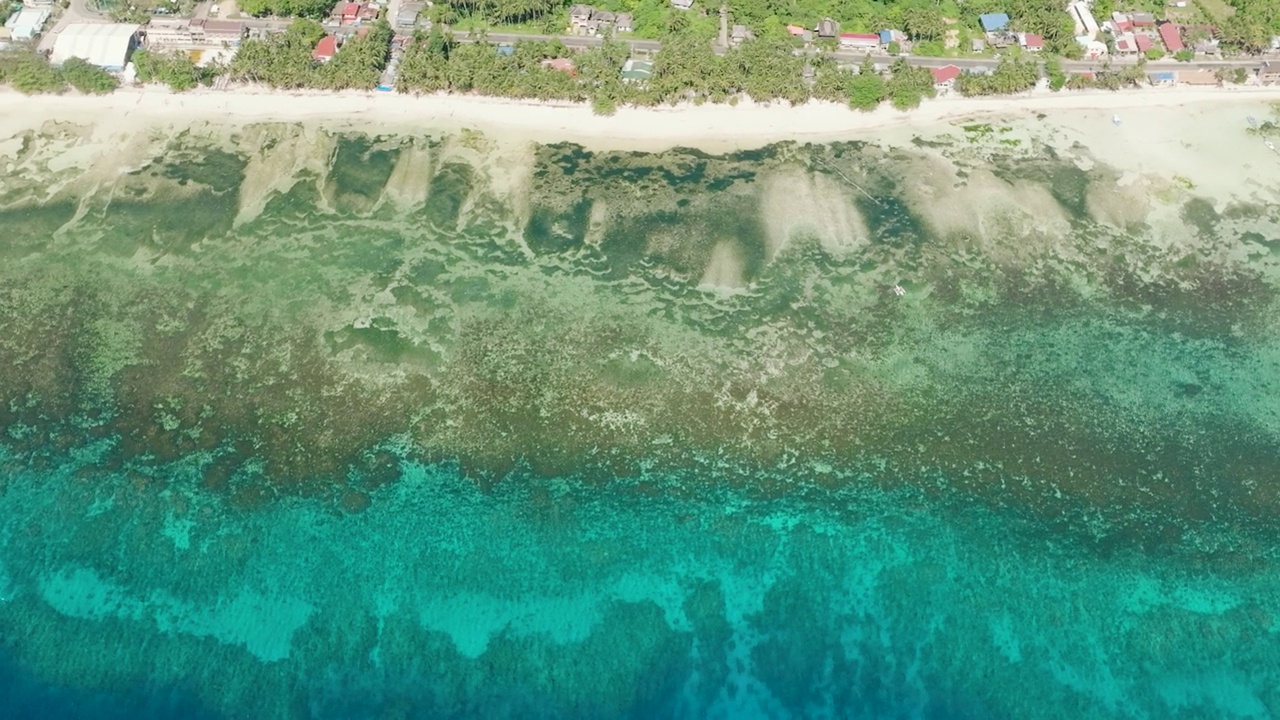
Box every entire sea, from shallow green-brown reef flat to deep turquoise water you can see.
[0,124,1280,719]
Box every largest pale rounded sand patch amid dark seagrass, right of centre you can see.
[760,168,868,261]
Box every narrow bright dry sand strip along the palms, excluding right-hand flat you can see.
[0,87,1280,150]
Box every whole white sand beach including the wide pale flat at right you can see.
[0,87,1280,213]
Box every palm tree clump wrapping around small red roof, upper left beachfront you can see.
[228,19,392,90]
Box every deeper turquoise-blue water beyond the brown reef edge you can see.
[0,438,1280,719]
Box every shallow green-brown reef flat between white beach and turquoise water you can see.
[0,126,1280,546]
